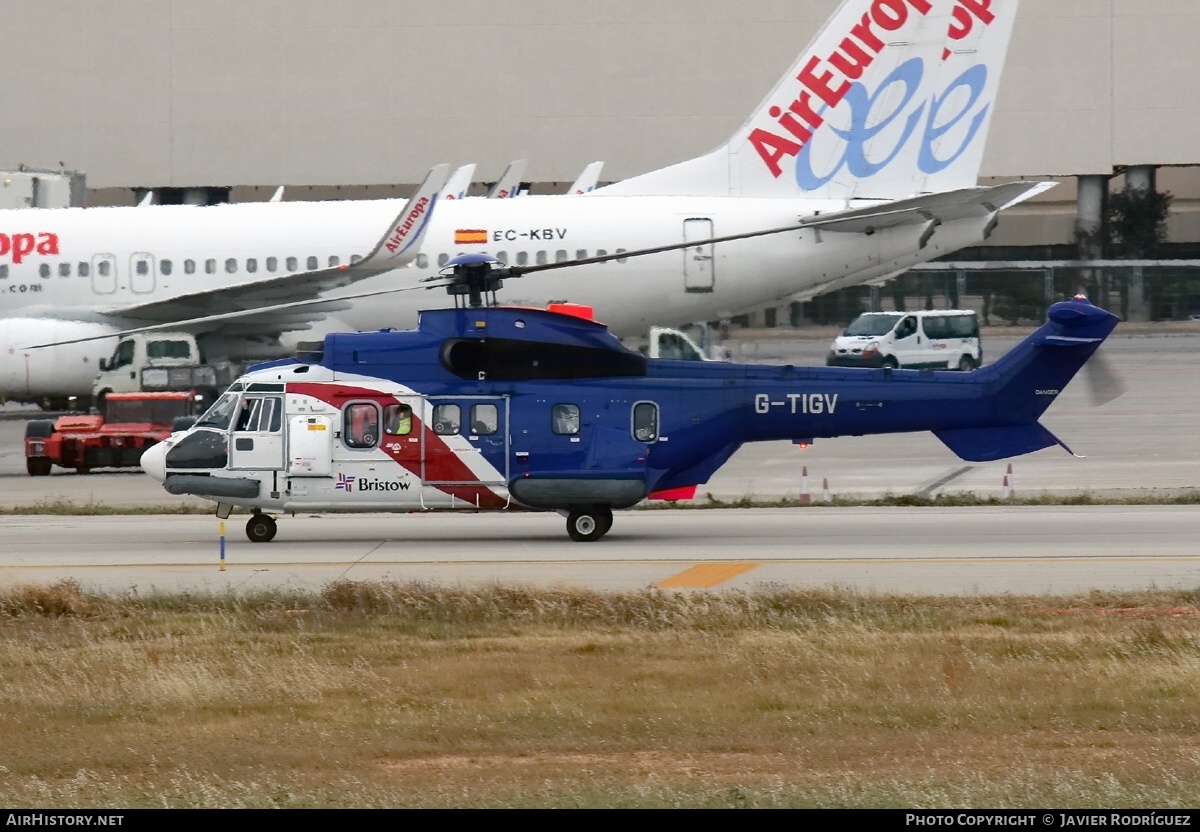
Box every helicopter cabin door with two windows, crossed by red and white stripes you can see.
[425,396,509,485]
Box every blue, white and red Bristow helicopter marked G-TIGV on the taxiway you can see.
[142,246,1118,541]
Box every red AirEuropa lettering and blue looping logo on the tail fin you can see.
[749,0,995,181]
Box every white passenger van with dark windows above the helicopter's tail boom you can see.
[826,309,983,370]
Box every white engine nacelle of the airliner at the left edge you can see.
[0,318,119,402]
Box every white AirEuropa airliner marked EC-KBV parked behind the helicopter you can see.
[0,0,1048,400]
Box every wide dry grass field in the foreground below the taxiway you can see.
[0,582,1200,808]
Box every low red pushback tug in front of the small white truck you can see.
[25,393,196,477]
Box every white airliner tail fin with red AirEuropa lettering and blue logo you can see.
[598,0,1018,200]
